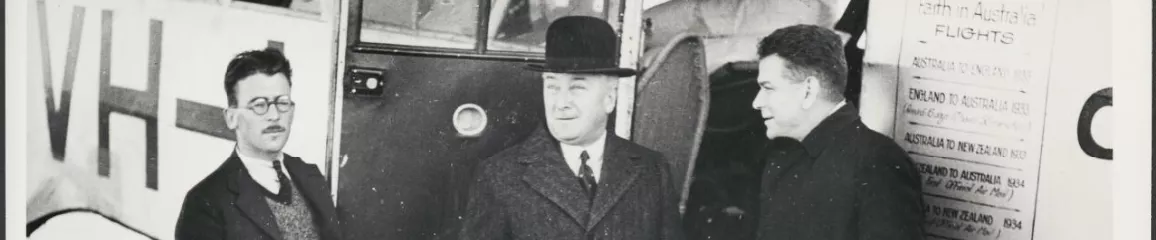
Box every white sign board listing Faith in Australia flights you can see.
[894,0,1055,239]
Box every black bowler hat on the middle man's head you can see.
[526,16,636,77]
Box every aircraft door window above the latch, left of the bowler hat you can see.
[361,0,479,50]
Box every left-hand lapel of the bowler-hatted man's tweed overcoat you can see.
[521,130,590,226]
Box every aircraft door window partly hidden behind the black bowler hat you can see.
[487,0,609,53]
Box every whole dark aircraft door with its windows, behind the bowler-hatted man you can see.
[336,0,621,239]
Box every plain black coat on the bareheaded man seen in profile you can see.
[757,104,924,240]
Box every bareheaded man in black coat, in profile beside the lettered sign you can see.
[753,25,924,240]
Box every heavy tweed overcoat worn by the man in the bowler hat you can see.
[459,129,683,240]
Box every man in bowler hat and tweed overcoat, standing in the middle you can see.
[459,16,683,240]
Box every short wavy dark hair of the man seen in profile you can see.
[758,24,847,100]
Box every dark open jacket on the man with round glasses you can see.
[176,152,341,240]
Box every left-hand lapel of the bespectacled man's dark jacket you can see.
[228,152,282,240]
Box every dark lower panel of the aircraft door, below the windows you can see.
[338,53,542,239]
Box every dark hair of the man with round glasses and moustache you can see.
[224,47,292,106]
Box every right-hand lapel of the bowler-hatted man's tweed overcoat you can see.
[586,136,642,231]
